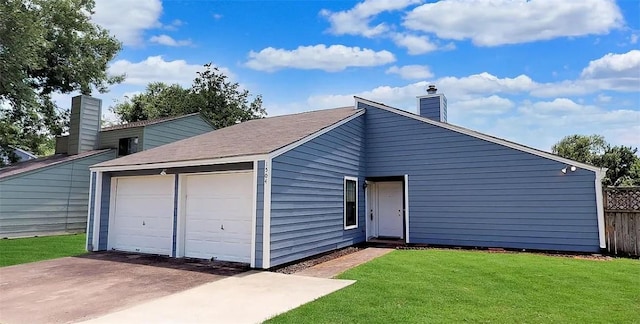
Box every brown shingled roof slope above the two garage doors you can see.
[94,107,361,167]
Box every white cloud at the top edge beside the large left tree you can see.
[91,0,162,46]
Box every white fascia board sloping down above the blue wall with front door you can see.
[355,97,600,173]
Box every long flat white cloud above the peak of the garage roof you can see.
[246,44,396,72]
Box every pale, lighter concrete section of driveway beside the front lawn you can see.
[83,271,355,324]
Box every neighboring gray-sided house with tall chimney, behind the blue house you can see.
[0,96,213,237]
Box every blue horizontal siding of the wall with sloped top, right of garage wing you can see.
[359,103,599,252]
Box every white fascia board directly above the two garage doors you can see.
[89,154,268,172]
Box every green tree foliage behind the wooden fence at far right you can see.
[551,135,640,186]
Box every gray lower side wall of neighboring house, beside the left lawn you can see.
[0,151,115,237]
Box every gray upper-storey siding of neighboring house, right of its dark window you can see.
[141,115,213,150]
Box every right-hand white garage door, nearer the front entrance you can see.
[184,172,253,263]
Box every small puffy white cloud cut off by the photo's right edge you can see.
[580,50,640,80]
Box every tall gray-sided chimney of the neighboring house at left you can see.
[67,95,102,155]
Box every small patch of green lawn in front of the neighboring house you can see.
[0,234,87,267]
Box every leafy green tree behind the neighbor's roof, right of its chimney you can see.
[111,63,266,128]
